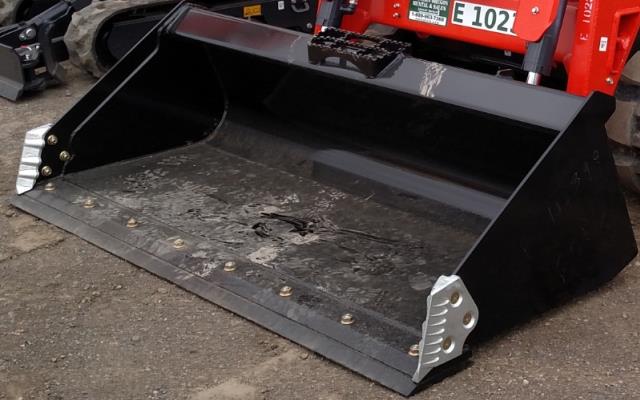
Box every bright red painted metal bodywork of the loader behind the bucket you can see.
[318,0,640,96]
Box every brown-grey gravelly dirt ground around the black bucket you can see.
[0,65,640,400]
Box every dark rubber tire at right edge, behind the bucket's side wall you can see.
[607,52,640,193]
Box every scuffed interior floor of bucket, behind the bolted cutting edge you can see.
[66,143,484,330]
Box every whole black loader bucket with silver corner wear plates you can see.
[14,5,636,395]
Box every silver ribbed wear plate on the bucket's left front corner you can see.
[16,124,51,194]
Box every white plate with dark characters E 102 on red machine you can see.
[451,1,516,36]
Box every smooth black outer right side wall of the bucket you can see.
[457,93,637,340]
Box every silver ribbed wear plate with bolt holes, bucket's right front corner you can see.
[413,275,478,382]
